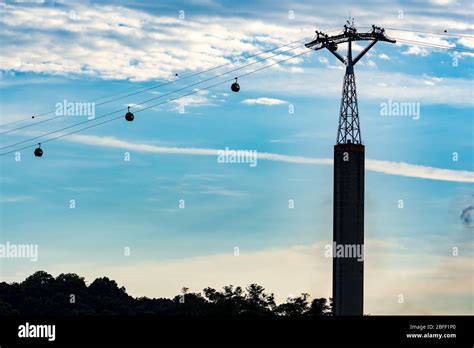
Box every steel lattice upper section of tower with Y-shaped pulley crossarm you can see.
[305,23,395,144]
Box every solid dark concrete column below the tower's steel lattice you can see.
[333,143,365,315]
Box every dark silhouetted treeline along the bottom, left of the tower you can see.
[0,271,331,316]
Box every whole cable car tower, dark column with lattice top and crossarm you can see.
[305,20,395,315]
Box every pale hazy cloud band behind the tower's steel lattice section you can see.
[247,64,474,107]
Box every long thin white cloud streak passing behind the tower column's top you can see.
[56,134,474,183]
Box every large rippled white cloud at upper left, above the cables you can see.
[0,3,310,81]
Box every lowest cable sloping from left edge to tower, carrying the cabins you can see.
[0,50,311,156]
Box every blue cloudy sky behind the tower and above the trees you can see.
[0,0,474,314]
